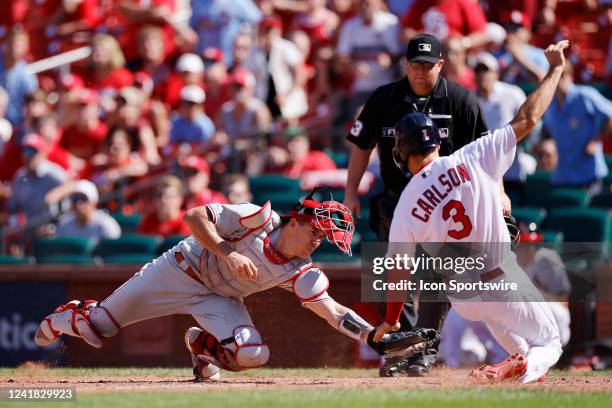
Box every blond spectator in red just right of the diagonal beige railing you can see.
[77,34,136,91]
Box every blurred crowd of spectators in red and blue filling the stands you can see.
[0,0,612,255]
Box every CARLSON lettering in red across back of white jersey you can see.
[411,163,472,222]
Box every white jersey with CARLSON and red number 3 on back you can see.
[389,125,516,267]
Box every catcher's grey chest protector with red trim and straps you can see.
[183,206,311,297]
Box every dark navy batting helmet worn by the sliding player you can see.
[393,112,440,173]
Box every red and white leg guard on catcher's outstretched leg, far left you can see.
[34,300,103,348]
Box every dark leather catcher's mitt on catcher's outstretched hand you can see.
[368,329,440,363]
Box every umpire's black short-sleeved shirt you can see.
[346,76,489,197]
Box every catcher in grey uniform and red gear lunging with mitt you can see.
[35,190,436,381]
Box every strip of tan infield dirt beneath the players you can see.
[0,366,612,393]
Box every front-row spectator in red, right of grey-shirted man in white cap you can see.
[138,176,190,237]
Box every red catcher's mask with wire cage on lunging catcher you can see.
[286,190,355,256]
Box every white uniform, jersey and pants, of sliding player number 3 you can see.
[389,125,561,383]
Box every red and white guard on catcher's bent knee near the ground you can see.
[185,326,270,371]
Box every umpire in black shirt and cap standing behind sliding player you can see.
[344,34,489,376]
